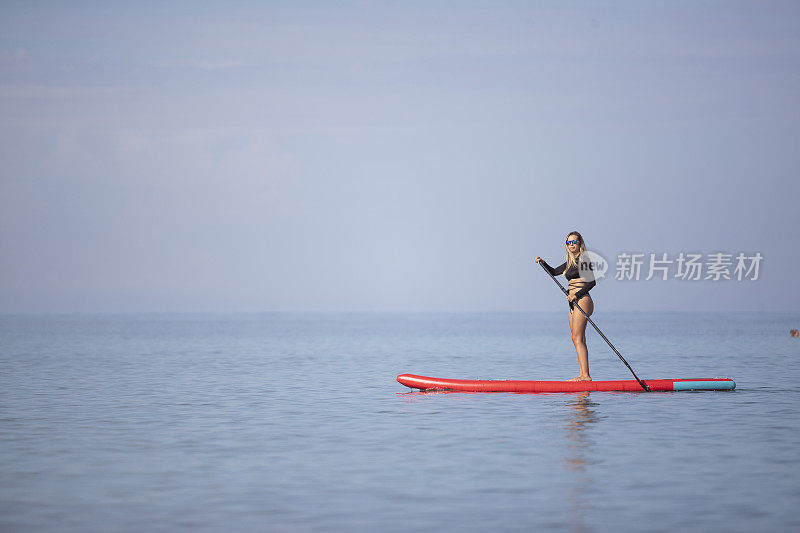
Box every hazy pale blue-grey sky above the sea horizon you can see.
[0,0,800,312]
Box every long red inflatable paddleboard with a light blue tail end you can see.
[397,374,736,392]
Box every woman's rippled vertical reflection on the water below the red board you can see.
[564,392,598,532]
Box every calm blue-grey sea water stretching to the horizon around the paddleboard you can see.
[0,312,800,532]
